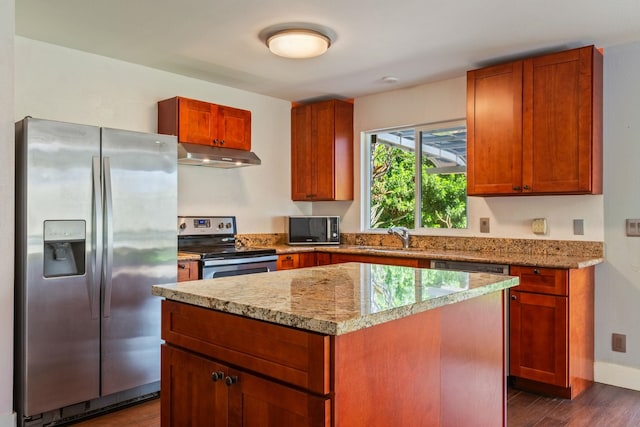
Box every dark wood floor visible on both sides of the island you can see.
[74,383,640,427]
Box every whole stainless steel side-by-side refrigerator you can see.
[14,117,177,426]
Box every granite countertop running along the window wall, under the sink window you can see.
[275,245,604,268]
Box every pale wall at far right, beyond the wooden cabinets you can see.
[595,42,640,389]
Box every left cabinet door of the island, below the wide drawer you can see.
[160,344,229,427]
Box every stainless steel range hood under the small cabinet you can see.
[178,142,262,168]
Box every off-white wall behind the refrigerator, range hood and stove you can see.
[15,37,310,233]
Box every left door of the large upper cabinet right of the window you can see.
[467,61,522,196]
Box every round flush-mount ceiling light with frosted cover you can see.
[266,28,331,59]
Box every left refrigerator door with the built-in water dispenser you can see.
[15,118,100,416]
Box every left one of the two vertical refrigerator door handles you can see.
[89,156,102,319]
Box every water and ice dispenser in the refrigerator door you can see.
[44,220,87,277]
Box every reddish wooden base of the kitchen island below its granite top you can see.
[161,298,506,427]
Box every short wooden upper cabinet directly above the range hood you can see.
[158,97,251,151]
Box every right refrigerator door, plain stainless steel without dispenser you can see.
[102,128,178,395]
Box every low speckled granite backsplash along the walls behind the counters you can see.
[236,233,604,258]
